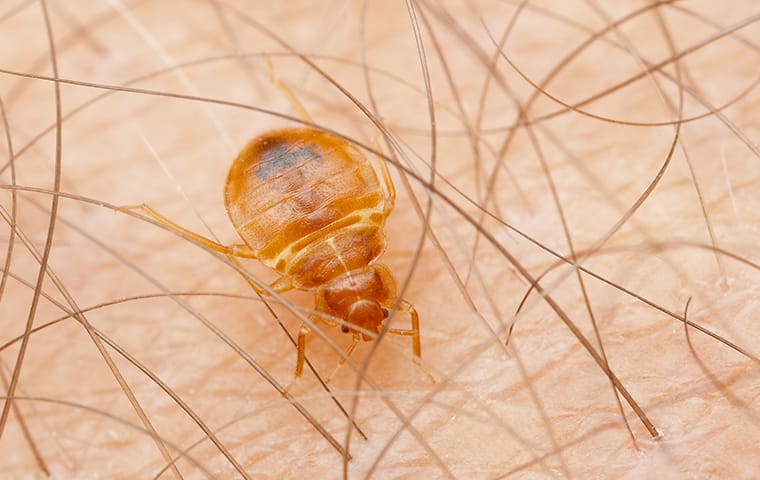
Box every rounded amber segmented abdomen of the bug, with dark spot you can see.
[225,129,387,288]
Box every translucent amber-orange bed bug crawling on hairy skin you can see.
[127,128,427,385]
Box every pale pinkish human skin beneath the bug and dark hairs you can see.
[0,0,760,479]
